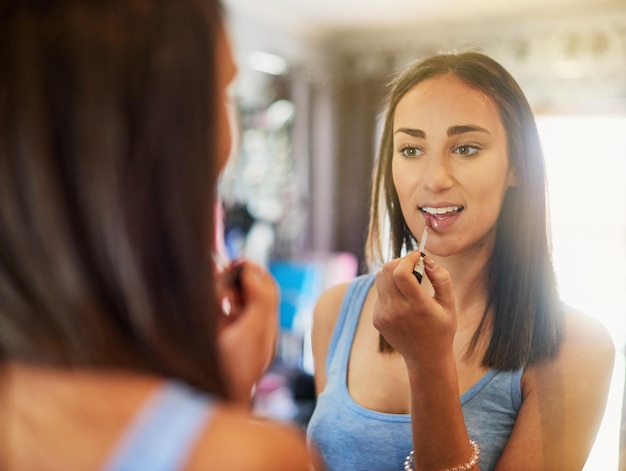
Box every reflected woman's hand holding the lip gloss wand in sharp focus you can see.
[373,251,456,364]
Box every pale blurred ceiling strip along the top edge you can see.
[224,0,626,40]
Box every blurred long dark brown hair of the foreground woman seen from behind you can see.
[0,0,227,395]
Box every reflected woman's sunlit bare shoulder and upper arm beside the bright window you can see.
[498,309,615,469]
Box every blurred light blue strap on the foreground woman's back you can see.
[102,381,213,471]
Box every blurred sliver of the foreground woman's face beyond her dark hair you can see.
[216,23,238,172]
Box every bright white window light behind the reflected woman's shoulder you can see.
[537,116,626,471]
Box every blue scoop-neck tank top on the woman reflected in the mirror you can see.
[307,274,523,471]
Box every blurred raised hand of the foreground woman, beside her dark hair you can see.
[218,261,279,403]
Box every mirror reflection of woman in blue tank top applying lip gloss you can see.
[308,52,614,471]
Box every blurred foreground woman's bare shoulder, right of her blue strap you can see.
[186,405,314,471]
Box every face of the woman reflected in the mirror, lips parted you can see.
[392,75,515,256]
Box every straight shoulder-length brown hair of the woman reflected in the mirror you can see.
[366,51,563,370]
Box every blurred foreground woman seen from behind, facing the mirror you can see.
[0,0,311,471]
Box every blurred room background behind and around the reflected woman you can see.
[220,0,626,471]
